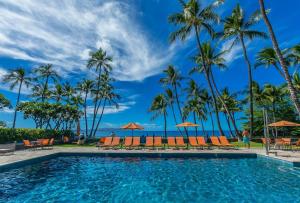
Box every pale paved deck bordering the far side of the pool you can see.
[0,147,300,170]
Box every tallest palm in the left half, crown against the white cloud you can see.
[87,48,112,136]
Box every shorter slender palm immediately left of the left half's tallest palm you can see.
[77,80,94,136]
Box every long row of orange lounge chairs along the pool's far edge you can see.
[97,136,235,149]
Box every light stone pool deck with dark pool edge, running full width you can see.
[0,147,300,169]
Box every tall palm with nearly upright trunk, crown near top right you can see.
[222,4,267,137]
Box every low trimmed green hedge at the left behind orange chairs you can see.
[0,128,74,144]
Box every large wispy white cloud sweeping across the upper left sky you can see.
[0,0,174,81]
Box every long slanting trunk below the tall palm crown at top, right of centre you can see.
[195,27,224,135]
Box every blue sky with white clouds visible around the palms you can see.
[0,0,300,130]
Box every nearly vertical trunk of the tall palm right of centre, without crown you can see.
[239,34,254,138]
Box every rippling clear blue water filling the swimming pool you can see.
[0,157,300,203]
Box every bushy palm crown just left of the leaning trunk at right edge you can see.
[254,48,284,77]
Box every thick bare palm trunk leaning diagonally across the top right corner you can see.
[259,0,300,114]
